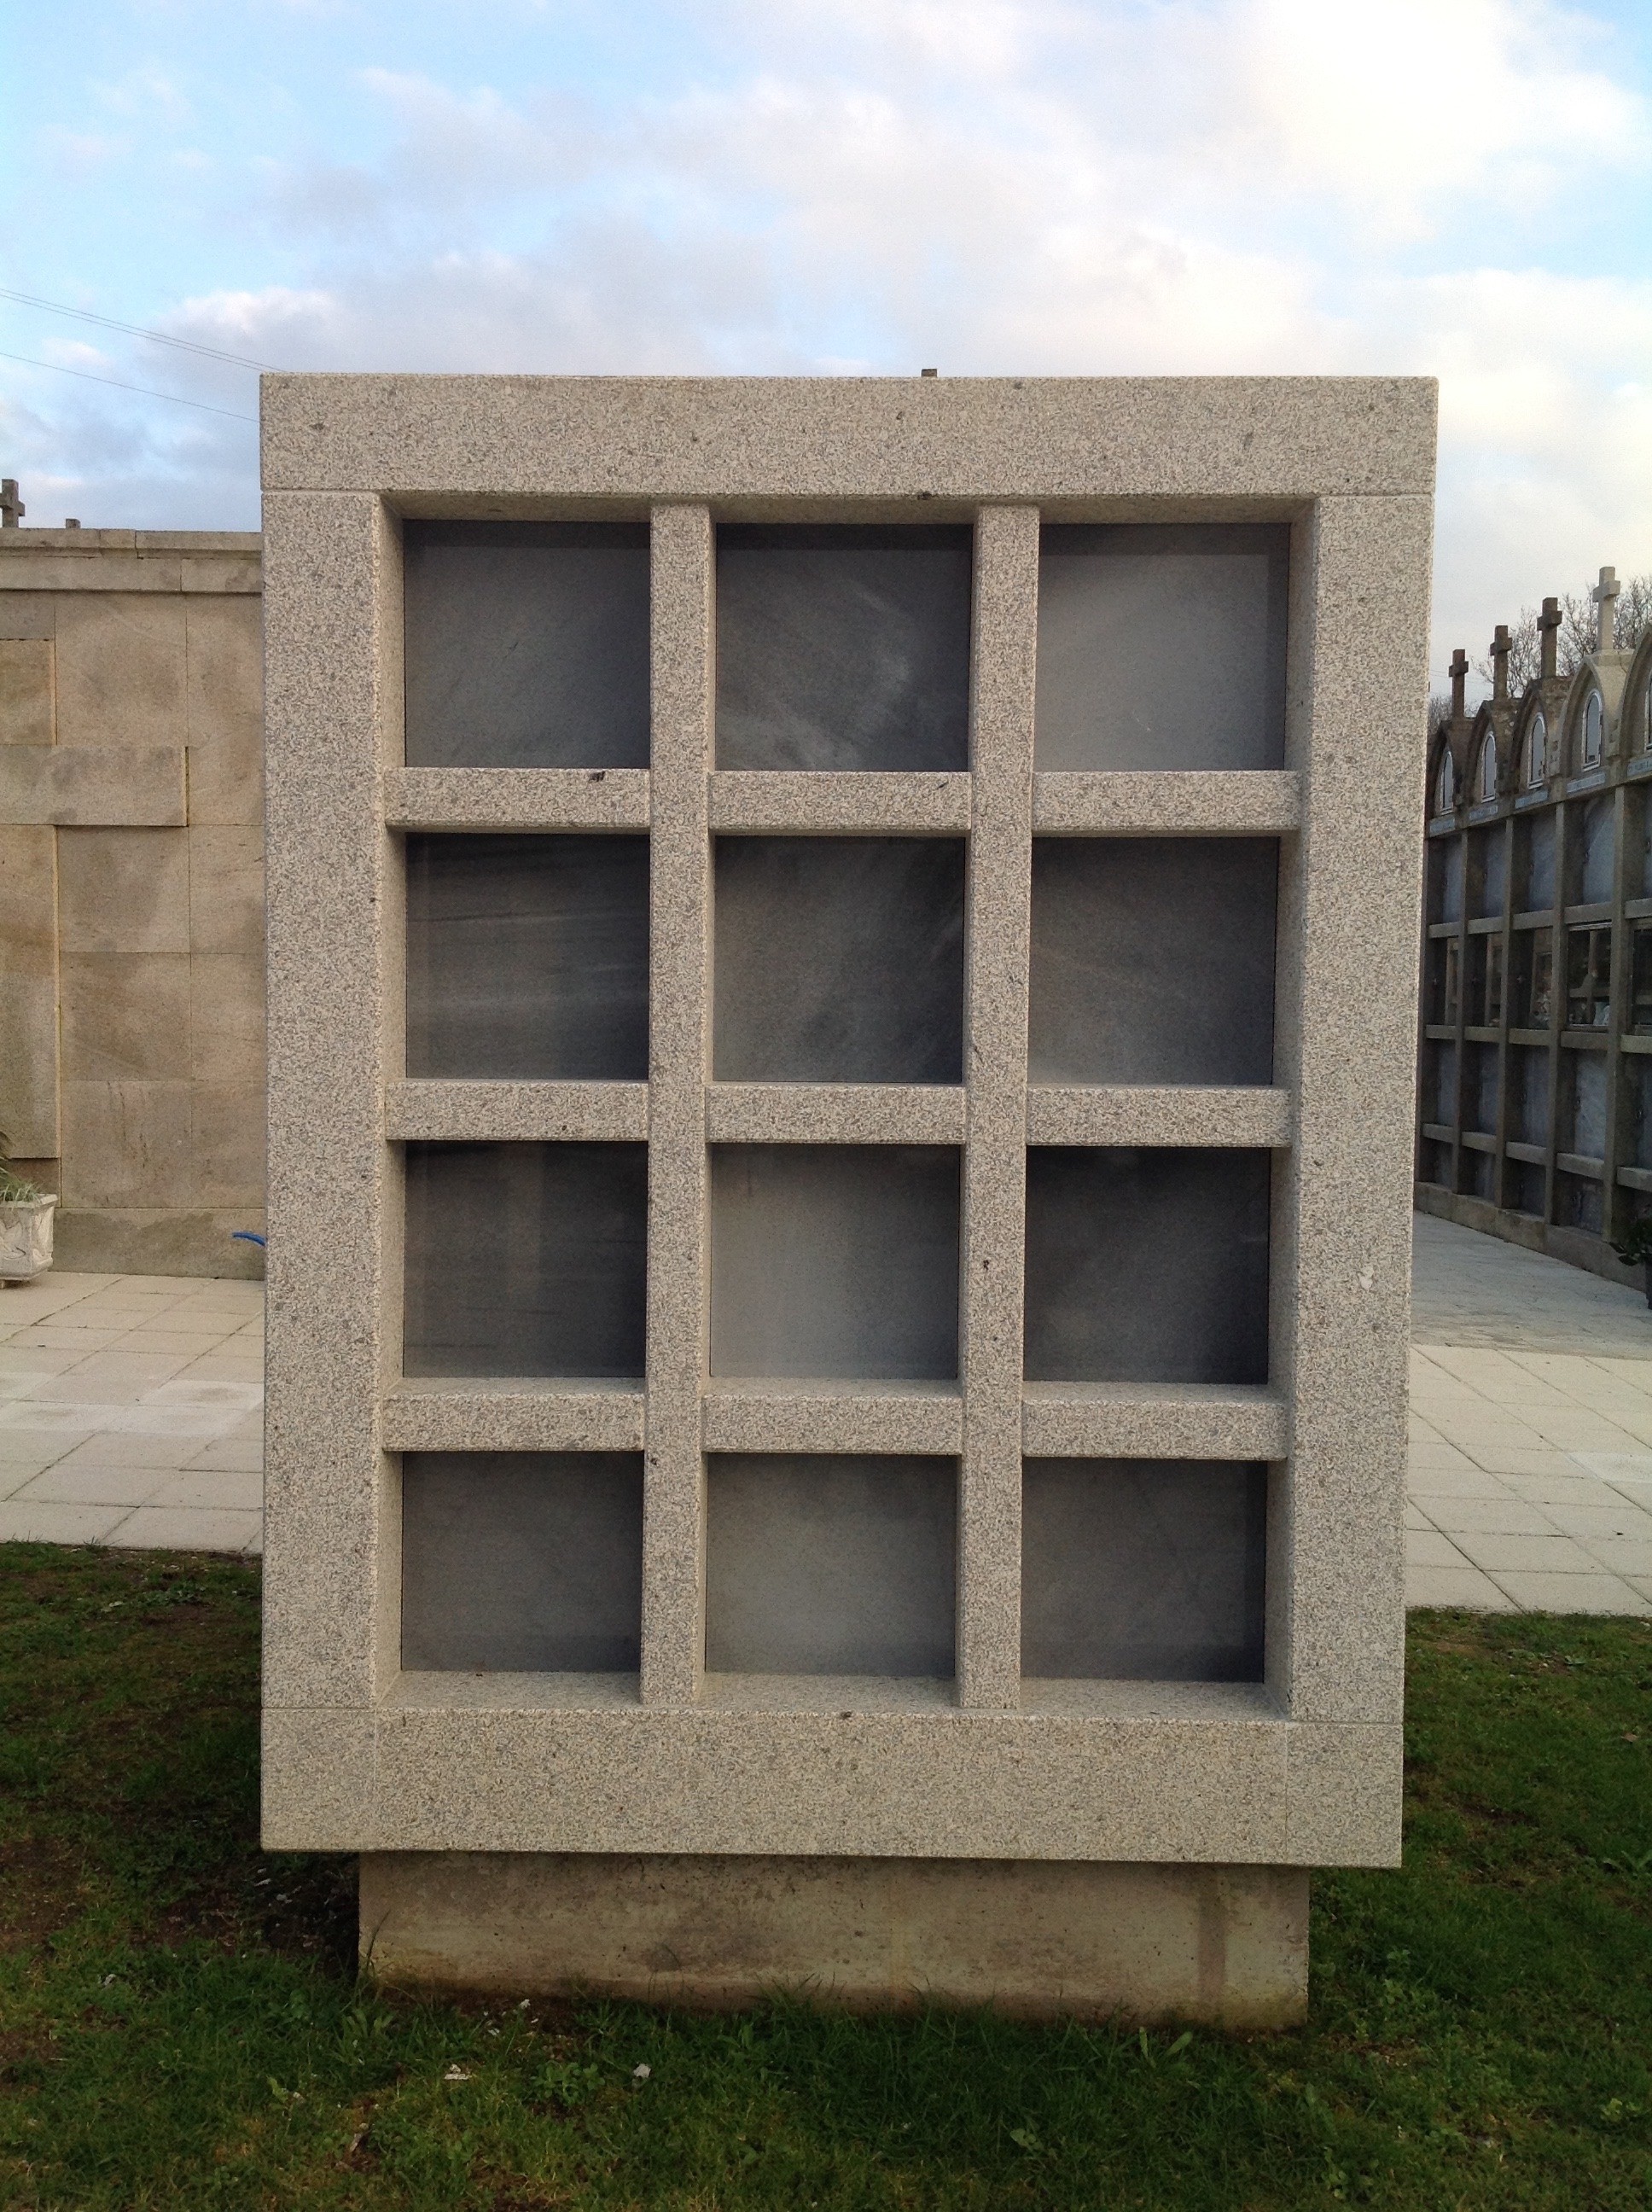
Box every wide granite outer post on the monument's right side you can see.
[1267,496,1431,1743]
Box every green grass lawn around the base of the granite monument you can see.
[0,1544,1652,2212]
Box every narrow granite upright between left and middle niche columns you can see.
[642,504,714,1705]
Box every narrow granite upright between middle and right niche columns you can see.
[957,507,1039,1712]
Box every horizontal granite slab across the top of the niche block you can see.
[261,376,1438,504]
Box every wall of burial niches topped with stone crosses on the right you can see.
[1416,588,1652,1283]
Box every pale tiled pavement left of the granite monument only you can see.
[0,1274,263,1551]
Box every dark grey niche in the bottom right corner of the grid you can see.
[1021,1460,1267,1681]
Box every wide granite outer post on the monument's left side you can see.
[263,493,400,1716]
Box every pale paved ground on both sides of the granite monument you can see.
[0,1214,1652,1615]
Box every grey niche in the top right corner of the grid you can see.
[1032,524,1289,772]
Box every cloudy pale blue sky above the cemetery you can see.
[0,0,1652,690]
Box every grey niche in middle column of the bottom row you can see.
[706,1453,957,1674]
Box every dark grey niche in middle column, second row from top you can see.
[713,836,964,1084]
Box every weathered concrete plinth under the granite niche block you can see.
[360,1852,1307,2029]
